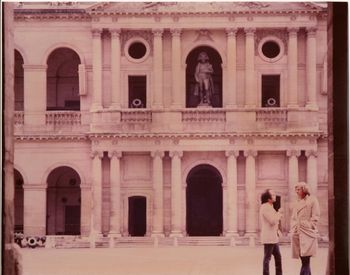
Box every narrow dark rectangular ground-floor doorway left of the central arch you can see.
[129,196,146,237]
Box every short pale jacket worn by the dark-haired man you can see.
[259,202,281,244]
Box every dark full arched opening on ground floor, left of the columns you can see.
[46,166,81,235]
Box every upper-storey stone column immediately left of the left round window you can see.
[110,29,121,110]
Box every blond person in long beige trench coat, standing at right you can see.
[291,182,320,275]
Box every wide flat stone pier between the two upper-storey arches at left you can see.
[23,64,47,125]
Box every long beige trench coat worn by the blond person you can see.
[291,196,320,258]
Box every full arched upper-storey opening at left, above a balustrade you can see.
[47,48,81,111]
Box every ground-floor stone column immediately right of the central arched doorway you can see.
[225,151,239,236]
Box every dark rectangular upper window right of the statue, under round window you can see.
[261,75,280,107]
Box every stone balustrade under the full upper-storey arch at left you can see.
[46,111,81,126]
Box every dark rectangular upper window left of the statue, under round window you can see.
[129,75,147,108]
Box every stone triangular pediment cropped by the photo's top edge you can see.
[87,2,324,14]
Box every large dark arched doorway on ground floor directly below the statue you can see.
[186,164,223,236]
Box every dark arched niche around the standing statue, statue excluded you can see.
[186,46,222,108]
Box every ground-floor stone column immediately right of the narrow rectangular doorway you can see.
[151,151,164,236]
